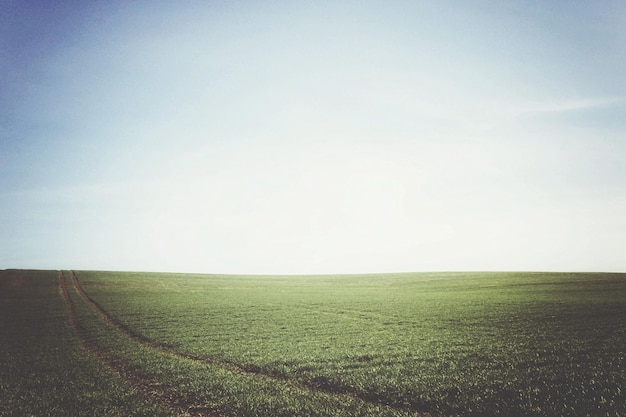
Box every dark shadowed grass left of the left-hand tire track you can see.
[0,271,174,417]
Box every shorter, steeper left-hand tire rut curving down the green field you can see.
[59,271,216,417]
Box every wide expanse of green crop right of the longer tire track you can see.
[78,272,626,416]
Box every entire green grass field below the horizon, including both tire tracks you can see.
[0,270,626,416]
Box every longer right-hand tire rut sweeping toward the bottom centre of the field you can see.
[70,271,420,416]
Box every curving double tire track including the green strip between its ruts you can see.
[62,272,407,416]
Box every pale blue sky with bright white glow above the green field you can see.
[0,0,626,274]
